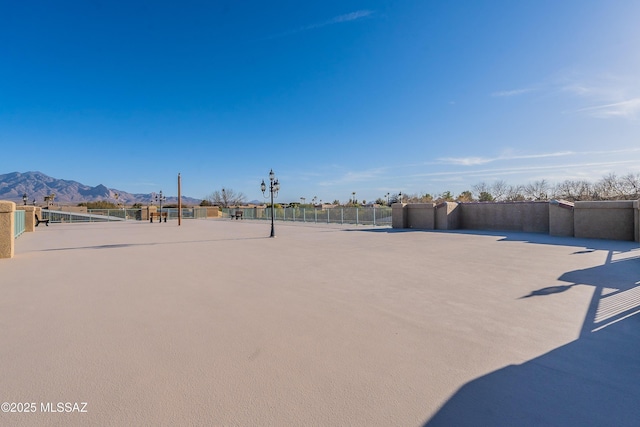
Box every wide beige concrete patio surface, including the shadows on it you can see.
[0,220,640,427]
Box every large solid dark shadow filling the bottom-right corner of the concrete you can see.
[424,316,640,427]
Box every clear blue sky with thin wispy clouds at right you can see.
[0,0,640,201]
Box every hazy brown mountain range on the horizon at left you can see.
[0,172,202,205]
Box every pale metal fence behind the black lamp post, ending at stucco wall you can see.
[221,207,391,226]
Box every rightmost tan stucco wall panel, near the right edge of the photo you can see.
[573,200,635,240]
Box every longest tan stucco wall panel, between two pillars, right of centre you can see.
[458,202,549,233]
